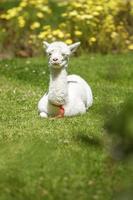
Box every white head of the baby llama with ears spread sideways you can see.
[43,41,80,68]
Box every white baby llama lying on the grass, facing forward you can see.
[38,42,93,118]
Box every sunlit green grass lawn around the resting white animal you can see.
[0,54,133,200]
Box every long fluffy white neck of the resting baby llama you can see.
[48,67,68,105]
